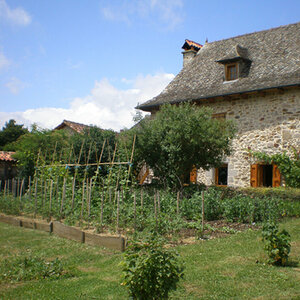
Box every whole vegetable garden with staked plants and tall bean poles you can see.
[0,140,300,243]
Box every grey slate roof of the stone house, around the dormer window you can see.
[137,22,300,111]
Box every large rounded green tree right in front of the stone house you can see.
[130,103,235,188]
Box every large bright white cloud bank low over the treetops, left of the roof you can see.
[0,73,174,130]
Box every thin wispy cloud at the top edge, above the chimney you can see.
[101,0,183,30]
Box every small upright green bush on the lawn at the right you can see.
[262,223,291,265]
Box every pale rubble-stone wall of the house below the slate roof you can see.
[197,88,300,187]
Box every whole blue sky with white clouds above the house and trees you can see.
[0,0,300,131]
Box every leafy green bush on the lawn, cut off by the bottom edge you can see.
[122,235,183,300]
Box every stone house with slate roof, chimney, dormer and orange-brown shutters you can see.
[137,23,300,187]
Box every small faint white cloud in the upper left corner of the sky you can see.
[0,0,31,26]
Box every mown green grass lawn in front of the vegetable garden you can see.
[0,218,300,300]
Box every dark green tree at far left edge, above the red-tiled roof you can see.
[0,119,28,151]
